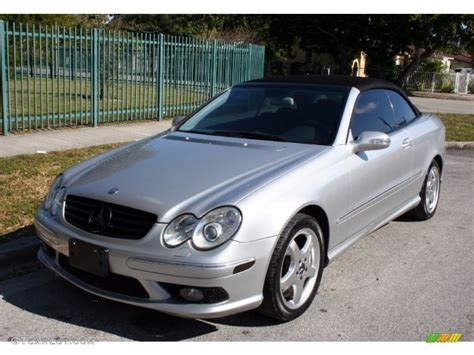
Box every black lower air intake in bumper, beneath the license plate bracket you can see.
[59,254,150,298]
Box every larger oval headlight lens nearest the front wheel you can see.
[192,207,242,250]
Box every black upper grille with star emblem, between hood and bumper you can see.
[64,195,158,239]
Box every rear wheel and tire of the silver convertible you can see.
[408,160,441,221]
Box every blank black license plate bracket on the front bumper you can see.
[69,239,109,277]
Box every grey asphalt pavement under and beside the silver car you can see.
[0,151,474,341]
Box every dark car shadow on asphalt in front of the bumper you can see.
[0,270,278,341]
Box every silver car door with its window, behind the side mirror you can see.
[339,89,412,238]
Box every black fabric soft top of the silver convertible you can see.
[244,75,401,92]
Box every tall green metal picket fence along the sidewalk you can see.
[0,21,265,135]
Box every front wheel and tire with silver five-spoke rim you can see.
[258,213,326,322]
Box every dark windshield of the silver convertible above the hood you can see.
[178,85,348,145]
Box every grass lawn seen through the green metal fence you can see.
[7,77,208,117]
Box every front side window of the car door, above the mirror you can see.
[351,89,396,139]
